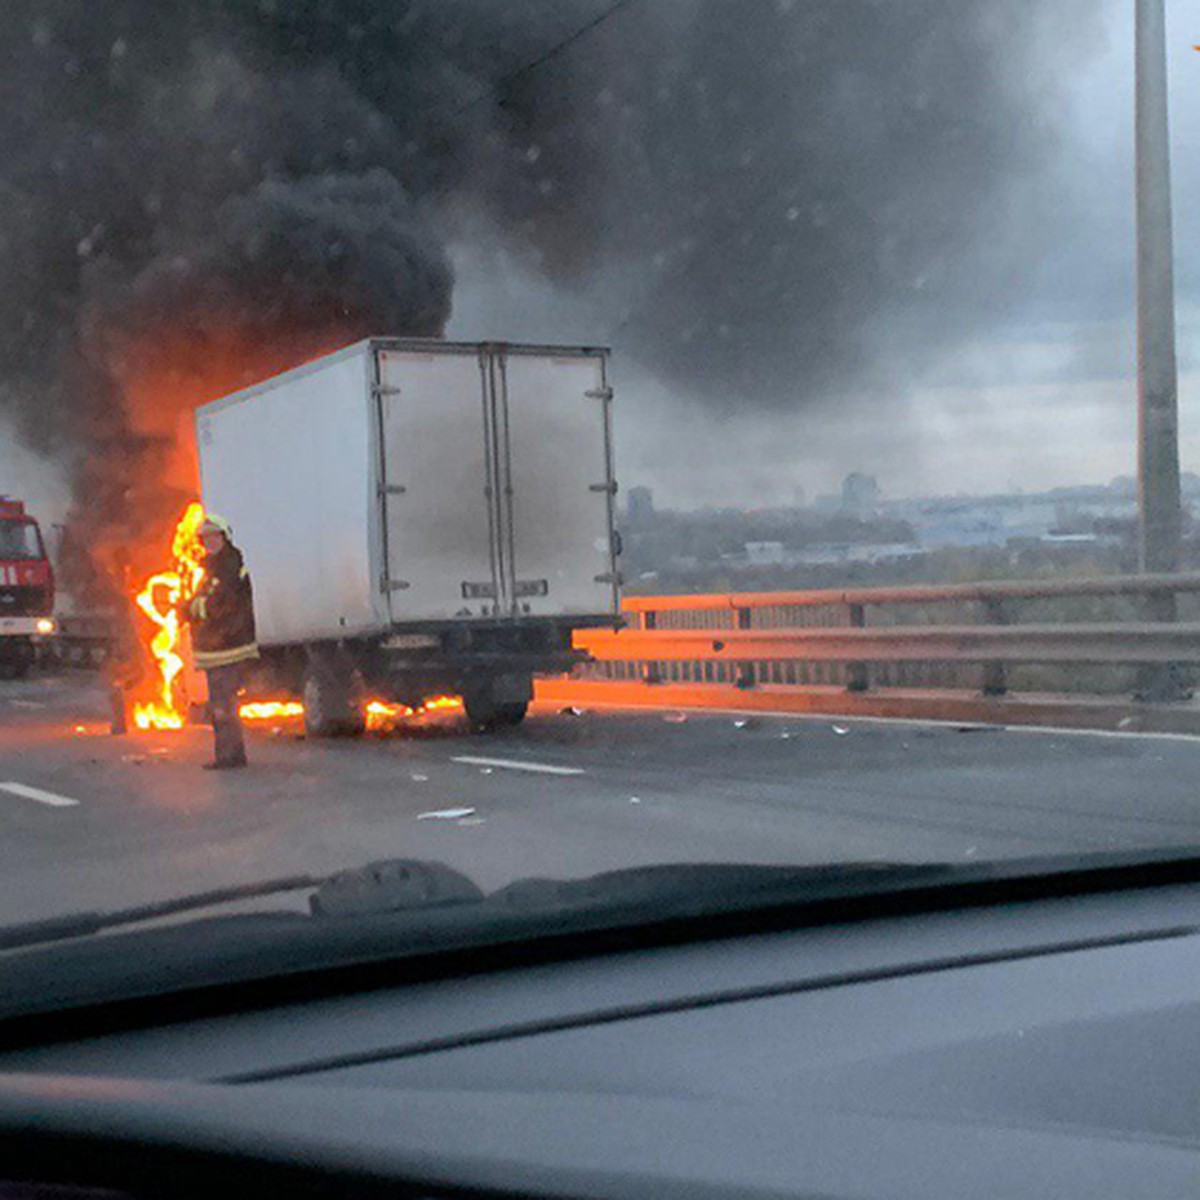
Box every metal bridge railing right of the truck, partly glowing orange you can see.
[576,572,1200,696]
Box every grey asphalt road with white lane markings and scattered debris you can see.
[0,674,1200,924]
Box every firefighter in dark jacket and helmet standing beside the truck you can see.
[185,512,258,770]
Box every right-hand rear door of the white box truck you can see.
[492,347,617,616]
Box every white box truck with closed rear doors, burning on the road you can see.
[196,338,620,736]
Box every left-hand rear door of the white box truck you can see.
[376,346,500,623]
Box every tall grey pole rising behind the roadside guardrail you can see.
[1135,0,1181,576]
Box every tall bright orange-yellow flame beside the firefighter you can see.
[133,503,204,730]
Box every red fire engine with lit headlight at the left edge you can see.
[0,496,56,678]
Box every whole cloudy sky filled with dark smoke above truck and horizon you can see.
[0,0,1200,528]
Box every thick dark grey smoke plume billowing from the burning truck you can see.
[0,0,1093,590]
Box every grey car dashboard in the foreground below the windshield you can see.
[0,884,1200,1200]
